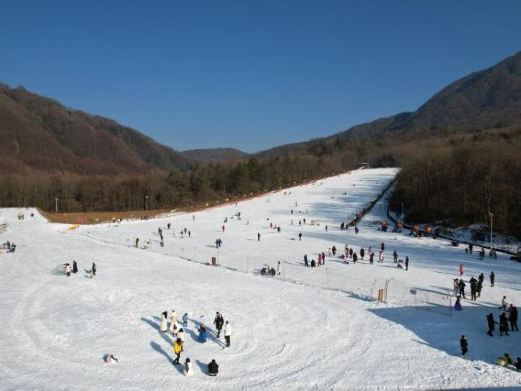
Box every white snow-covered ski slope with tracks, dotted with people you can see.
[0,169,521,390]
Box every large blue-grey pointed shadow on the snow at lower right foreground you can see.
[368,304,521,365]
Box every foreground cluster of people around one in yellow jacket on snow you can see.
[159,309,232,376]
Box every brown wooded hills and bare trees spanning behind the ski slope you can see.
[0,53,521,236]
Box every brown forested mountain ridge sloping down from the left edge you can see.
[0,84,191,175]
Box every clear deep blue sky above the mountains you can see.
[0,0,521,152]
